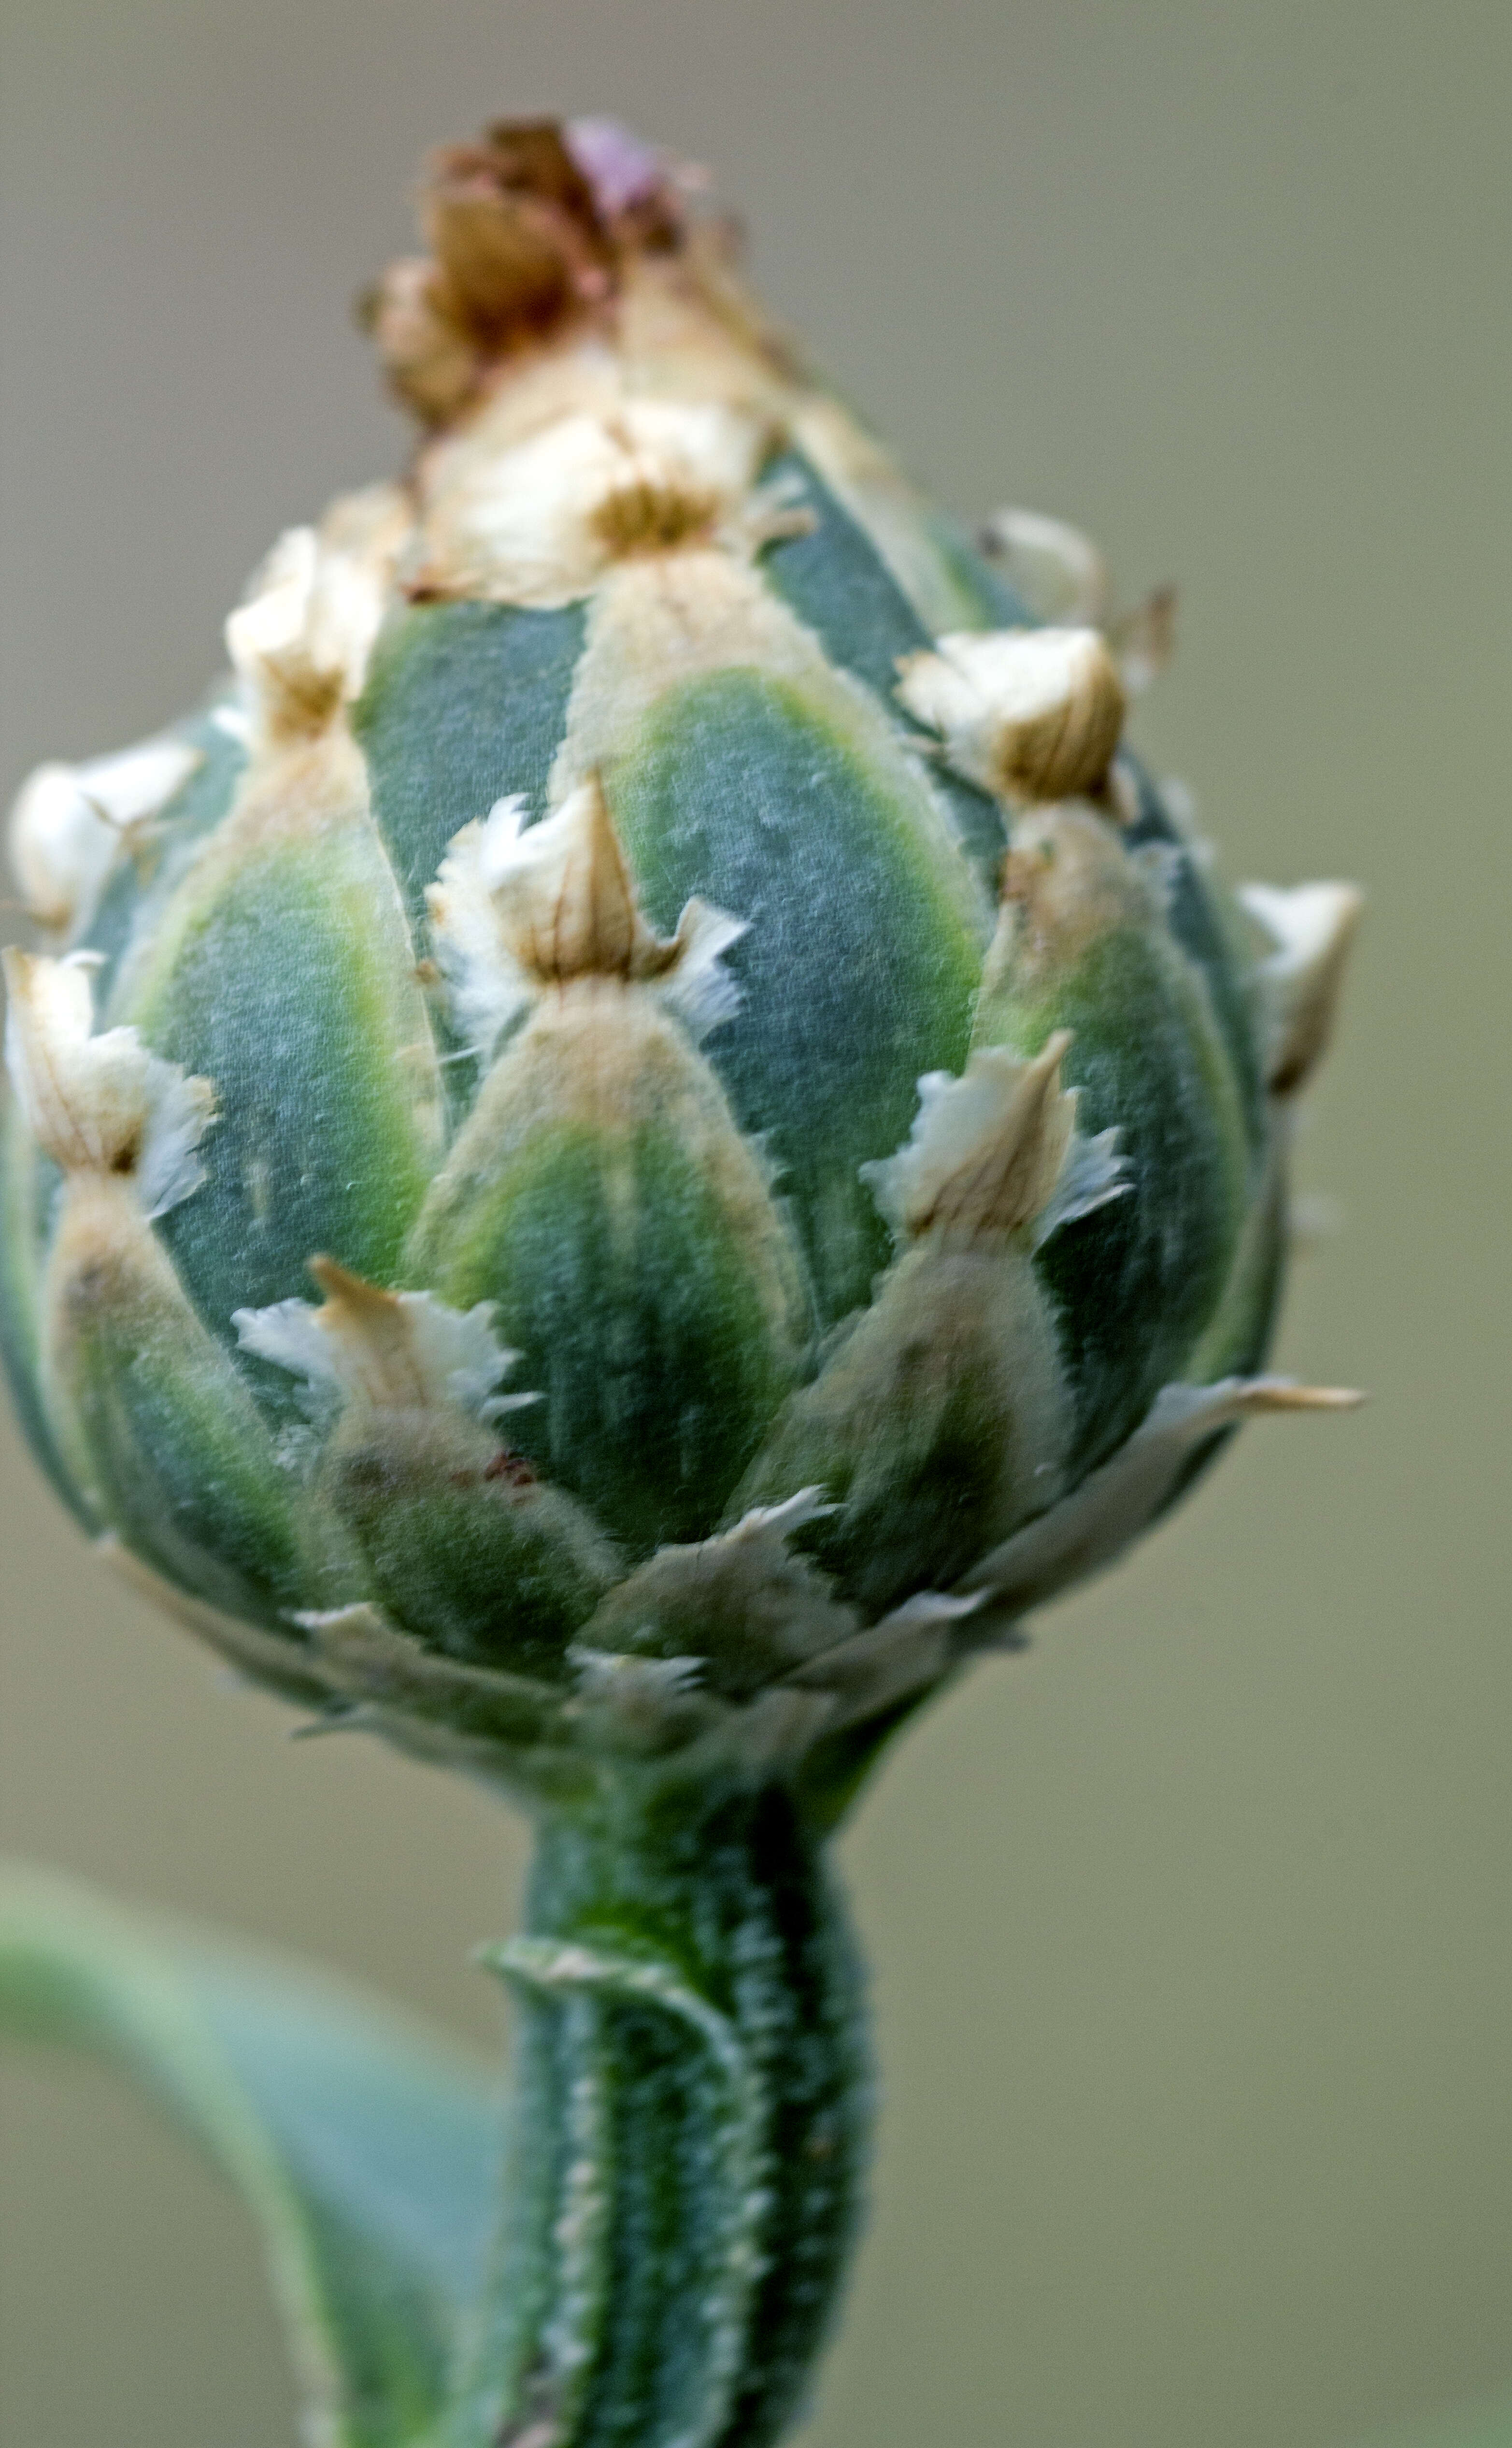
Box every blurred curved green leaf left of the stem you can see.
[0,1870,501,2448]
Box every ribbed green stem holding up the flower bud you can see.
[467,1780,869,2448]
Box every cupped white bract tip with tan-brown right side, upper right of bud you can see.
[898,629,1126,803]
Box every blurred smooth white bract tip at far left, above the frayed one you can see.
[10,739,203,935]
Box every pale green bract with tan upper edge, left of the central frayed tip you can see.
[122,737,443,1420]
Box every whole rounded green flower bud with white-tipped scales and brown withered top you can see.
[0,120,1358,1792]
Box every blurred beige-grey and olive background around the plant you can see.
[0,0,1512,2448]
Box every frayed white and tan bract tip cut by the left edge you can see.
[2,950,215,1214]
